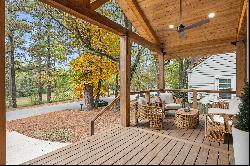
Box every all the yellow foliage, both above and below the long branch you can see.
[64,13,120,98]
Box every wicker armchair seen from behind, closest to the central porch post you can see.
[136,97,164,129]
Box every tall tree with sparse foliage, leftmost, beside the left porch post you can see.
[5,0,30,108]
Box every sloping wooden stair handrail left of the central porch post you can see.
[90,95,120,136]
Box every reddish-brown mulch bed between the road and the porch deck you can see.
[7,109,120,142]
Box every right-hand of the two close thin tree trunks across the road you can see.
[47,35,52,103]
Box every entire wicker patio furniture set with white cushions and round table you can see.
[136,93,240,142]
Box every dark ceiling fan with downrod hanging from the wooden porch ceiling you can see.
[169,0,215,39]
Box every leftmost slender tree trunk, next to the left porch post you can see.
[9,35,17,108]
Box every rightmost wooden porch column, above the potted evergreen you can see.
[236,41,247,96]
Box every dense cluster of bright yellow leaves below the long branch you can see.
[71,53,118,98]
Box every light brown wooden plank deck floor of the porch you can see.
[24,115,234,165]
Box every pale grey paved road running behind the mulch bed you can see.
[6,97,114,121]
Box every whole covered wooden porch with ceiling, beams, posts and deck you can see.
[0,0,249,165]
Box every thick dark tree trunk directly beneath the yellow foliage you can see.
[84,84,94,110]
